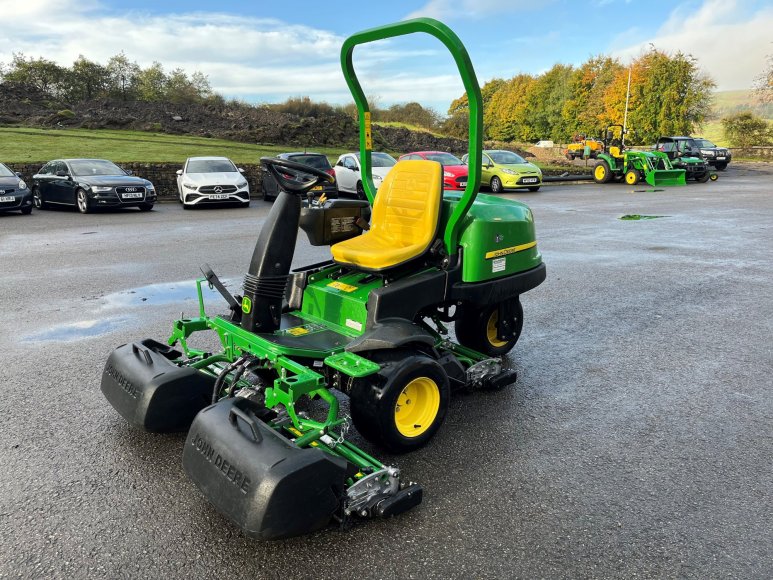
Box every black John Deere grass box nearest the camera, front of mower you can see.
[183,397,347,540]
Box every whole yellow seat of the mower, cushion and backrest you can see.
[330,160,443,270]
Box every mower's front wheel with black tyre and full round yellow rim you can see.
[349,349,451,453]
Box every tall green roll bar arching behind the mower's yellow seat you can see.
[341,18,483,256]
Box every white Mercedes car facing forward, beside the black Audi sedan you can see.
[177,157,250,209]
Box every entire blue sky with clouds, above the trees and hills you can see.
[0,0,773,113]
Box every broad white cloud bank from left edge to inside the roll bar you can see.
[0,0,463,109]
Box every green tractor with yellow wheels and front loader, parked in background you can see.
[593,125,686,187]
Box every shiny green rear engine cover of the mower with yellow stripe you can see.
[443,192,542,282]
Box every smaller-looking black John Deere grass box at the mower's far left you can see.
[101,340,215,433]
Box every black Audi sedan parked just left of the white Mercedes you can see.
[32,159,156,213]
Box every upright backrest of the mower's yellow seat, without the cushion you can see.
[368,160,443,248]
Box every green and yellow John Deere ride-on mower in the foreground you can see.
[102,18,545,539]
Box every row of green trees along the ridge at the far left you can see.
[0,52,217,104]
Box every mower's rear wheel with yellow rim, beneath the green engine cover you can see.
[454,298,523,356]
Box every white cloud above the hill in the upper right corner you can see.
[612,0,773,90]
